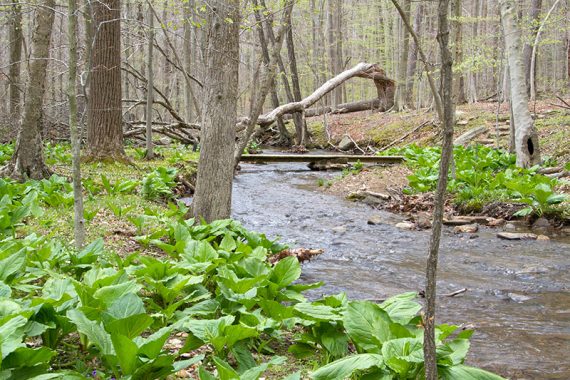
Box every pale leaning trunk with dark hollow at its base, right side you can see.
[499,0,540,168]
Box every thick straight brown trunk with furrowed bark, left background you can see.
[87,0,125,161]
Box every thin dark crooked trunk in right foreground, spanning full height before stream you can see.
[424,0,455,380]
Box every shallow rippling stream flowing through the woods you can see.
[227,160,570,379]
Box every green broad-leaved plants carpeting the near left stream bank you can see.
[0,145,500,380]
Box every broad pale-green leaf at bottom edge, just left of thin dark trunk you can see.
[311,354,383,380]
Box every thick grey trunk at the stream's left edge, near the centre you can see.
[192,0,240,222]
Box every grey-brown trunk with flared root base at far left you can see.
[0,0,55,180]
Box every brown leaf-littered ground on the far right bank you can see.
[300,99,570,229]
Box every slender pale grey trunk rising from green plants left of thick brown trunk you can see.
[67,0,85,249]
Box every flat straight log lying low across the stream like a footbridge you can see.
[241,154,404,164]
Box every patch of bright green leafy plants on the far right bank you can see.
[386,145,567,216]
